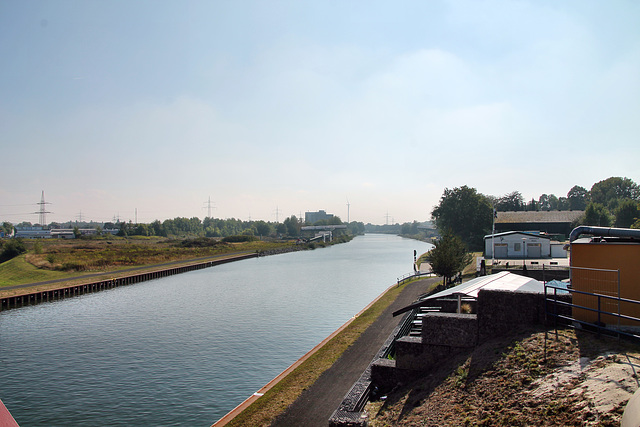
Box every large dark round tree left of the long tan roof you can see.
[431,185,493,250]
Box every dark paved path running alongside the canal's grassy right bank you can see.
[272,278,441,427]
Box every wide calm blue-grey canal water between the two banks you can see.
[0,234,430,427]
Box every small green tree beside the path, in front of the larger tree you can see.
[427,231,471,286]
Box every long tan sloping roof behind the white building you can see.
[496,211,584,240]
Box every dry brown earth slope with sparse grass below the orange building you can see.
[367,329,640,426]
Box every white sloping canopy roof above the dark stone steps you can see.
[425,271,544,300]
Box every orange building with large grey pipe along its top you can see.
[570,227,640,327]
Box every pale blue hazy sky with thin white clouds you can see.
[0,0,640,224]
